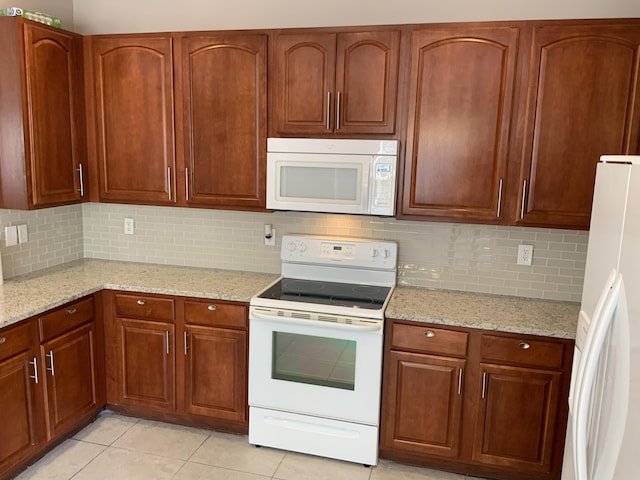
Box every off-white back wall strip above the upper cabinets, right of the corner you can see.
[72,0,640,33]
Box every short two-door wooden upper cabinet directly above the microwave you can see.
[270,29,400,136]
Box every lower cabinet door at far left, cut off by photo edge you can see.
[0,348,37,477]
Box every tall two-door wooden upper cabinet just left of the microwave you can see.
[87,33,267,209]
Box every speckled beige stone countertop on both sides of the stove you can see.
[0,259,580,338]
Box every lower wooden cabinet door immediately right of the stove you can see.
[381,350,465,457]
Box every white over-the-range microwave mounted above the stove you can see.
[267,138,398,216]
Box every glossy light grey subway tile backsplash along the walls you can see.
[0,203,588,302]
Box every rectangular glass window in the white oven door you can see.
[271,332,356,390]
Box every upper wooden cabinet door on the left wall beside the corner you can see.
[24,23,85,207]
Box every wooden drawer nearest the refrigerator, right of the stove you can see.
[480,335,565,368]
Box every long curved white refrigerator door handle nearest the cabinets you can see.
[572,275,622,480]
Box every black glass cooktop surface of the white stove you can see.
[259,278,391,310]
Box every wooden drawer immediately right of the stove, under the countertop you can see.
[391,323,469,357]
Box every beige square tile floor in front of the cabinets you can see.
[16,411,488,480]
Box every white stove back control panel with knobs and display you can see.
[281,235,398,269]
